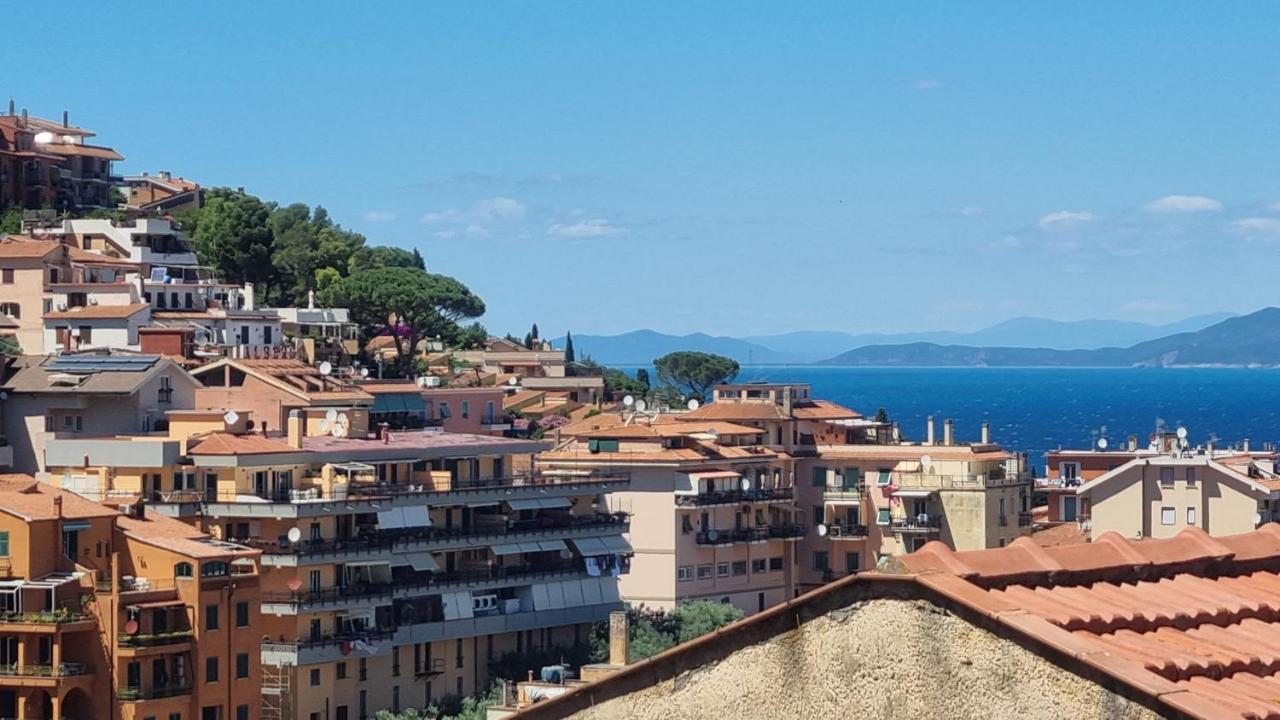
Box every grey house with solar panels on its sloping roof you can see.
[0,354,197,473]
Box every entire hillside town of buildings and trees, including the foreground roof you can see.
[0,101,1280,720]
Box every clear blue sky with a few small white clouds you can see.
[10,1,1280,334]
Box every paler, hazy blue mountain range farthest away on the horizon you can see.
[553,313,1231,365]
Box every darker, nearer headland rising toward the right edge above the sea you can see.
[822,307,1280,368]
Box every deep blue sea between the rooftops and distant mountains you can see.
[614,365,1280,474]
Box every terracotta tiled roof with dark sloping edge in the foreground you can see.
[518,524,1280,720]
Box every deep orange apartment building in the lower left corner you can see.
[0,475,261,720]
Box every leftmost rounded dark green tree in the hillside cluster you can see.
[191,187,279,297]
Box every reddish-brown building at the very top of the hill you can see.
[0,101,124,211]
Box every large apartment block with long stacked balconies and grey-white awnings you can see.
[47,406,630,720]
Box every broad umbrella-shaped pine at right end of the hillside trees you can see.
[323,268,484,375]
